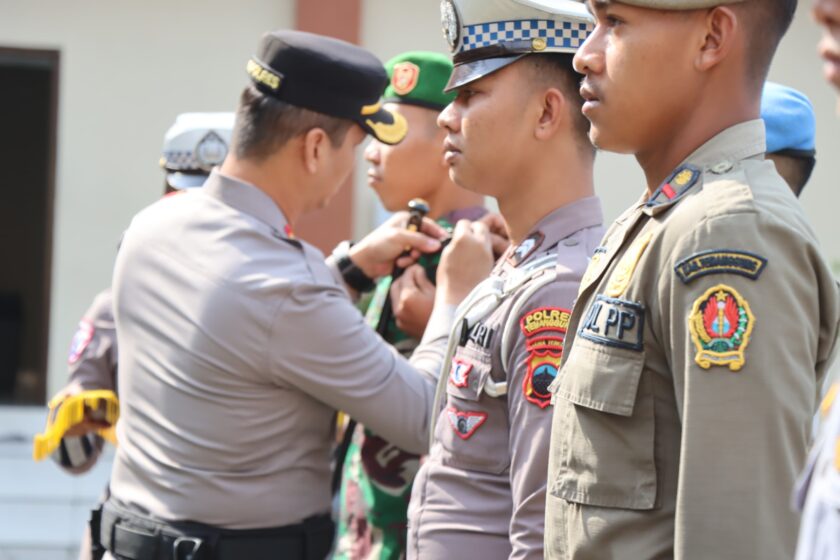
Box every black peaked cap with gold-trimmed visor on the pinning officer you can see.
[248,30,408,144]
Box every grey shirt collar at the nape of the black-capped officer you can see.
[201,170,294,237]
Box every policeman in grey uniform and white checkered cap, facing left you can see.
[408,0,603,560]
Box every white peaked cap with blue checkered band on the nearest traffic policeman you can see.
[440,0,593,91]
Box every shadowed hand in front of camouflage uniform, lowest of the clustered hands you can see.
[391,264,435,338]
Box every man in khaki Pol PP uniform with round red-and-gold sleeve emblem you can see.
[546,0,840,560]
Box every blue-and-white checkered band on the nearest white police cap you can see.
[461,19,592,52]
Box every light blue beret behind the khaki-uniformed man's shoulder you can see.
[761,82,817,154]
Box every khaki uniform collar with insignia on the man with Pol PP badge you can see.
[642,119,766,216]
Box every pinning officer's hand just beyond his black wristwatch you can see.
[350,212,446,278]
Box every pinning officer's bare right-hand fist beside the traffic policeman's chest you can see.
[436,220,495,305]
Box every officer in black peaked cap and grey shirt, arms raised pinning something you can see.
[98,31,492,560]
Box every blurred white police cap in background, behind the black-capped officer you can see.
[160,113,234,189]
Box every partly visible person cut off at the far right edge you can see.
[794,0,840,560]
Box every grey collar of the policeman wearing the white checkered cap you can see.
[506,196,604,266]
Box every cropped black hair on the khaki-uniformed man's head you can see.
[733,0,797,85]
